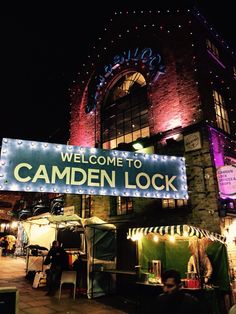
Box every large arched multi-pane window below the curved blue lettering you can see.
[101,71,149,149]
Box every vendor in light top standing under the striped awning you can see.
[187,239,213,284]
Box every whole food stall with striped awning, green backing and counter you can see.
[127,225,230,314]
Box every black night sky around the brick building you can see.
[0,0,236,143]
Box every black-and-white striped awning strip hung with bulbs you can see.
[127,225,226,243]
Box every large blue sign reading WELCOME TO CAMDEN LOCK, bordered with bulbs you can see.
[0,138,188,199]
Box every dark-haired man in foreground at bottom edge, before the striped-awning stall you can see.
[156,269,203,314]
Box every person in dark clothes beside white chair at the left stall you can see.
[44,241,69,296]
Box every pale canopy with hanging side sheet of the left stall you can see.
[23,213,116,298]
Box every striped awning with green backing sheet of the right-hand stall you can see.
[127,225,230,291]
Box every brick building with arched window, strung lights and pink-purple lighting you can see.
[67,9,236,266]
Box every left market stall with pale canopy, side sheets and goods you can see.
[23,213,116,298]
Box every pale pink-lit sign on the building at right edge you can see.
[217,165,236,199]
